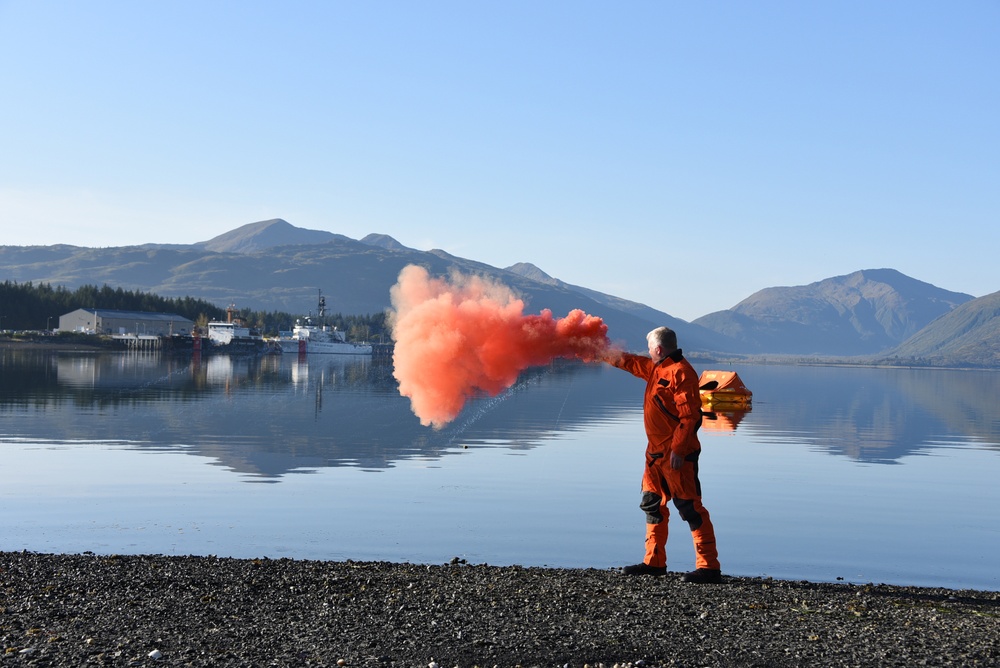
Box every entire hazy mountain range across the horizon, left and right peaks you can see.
[0,219,1000,367]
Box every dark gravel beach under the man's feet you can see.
[0,552,1000,668]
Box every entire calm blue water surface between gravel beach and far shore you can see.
[0,351,1000,590]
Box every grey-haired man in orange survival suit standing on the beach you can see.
[604,327,722,583]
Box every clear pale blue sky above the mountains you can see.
[0,0,1000,320]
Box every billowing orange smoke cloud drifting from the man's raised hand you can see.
[390,265,610,428]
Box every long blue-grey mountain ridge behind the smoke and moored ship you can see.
[0,220,724,352]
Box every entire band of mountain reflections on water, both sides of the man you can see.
[0,351,1000,474]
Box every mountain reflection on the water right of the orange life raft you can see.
[740,366,1000,463]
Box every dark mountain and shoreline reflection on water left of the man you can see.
[0,354,638,480]
